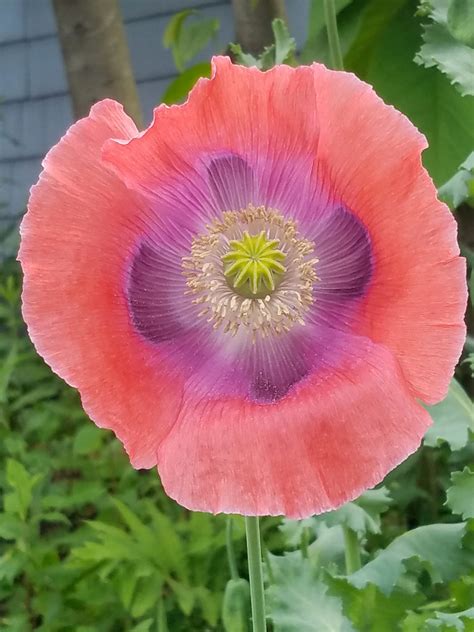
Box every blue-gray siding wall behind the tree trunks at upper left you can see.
[0,0,309,230]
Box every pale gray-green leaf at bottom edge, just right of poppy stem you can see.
[267,555,354,632]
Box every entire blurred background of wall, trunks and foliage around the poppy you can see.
[0,0,474,632]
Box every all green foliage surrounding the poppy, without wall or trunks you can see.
[0,0,474,632]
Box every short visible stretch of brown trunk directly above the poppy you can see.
[232,0,286,55]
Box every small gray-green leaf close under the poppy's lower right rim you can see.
[318,487,391,535]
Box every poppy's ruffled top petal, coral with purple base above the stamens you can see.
[104,57,319,218]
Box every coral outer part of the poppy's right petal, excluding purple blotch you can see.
[314,66,467,403]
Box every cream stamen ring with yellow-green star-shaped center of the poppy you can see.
[182,205,318,341]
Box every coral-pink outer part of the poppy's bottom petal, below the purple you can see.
[158,337,430,518]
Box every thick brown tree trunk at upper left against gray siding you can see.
[53,0,142,127]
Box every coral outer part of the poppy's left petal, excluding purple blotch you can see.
[19,100,181,467]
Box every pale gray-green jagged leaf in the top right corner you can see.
[415,0,474,95]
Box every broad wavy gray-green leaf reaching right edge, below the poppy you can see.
[347,523,474,595]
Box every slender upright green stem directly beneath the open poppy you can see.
[245,516,267,632]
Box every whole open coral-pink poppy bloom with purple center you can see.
[19,57,466,517]
